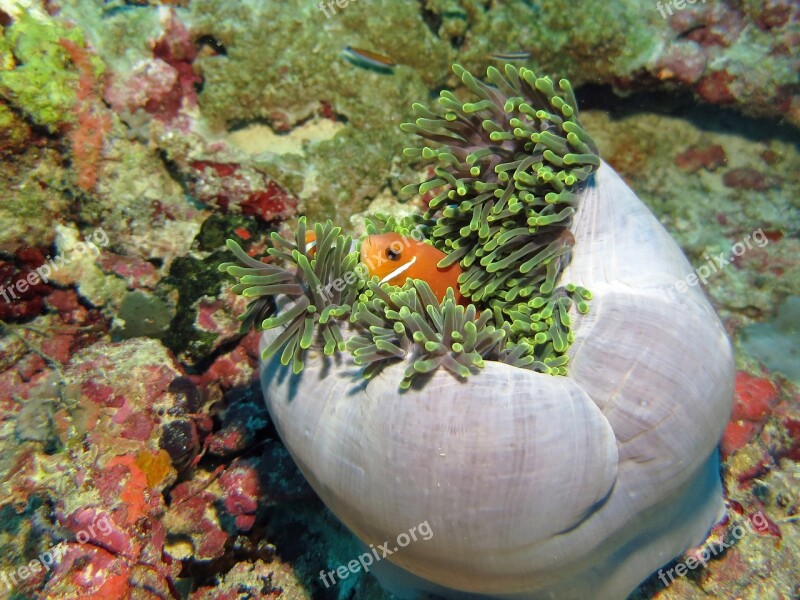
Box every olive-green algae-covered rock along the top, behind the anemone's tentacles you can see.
[181,0,661,229]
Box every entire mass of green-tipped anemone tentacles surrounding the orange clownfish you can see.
[220,65,600,388]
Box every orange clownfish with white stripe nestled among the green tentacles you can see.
[361,233,466,304]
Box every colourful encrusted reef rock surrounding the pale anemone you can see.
[0,0,800,600]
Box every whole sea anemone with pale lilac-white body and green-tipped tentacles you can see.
[225,67,734,600]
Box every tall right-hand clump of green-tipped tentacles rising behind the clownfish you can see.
[401,65,600,374]
